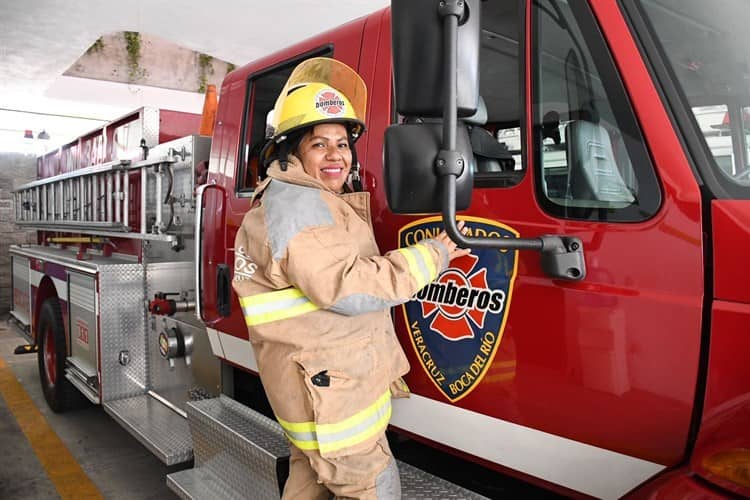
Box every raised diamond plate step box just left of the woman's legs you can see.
[187,396,289,499]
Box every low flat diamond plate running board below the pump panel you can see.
[103,394,193,465]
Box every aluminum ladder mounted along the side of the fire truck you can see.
[13,143,200,244]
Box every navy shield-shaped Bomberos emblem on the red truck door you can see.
[399,216,518,401]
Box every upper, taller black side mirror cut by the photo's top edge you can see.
[391,0,481,117]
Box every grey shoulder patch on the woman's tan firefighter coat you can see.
[263,179,333,260]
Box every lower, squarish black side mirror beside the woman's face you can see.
[385,122,474,214]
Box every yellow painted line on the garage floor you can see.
[0,358,103,500]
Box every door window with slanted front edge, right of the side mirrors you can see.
[532,0,661,221]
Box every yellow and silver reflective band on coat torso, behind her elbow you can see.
[240,288,319,326]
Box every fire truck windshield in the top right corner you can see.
[640,0,750,198]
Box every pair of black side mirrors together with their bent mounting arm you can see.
[385,0,586,281]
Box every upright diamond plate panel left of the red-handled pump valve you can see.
[99,264,149,402]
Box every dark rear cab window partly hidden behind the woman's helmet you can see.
[237,46,333,196]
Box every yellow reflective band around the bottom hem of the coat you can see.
[276,391,391,454]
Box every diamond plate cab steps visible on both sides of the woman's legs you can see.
[167,396,485,500]
